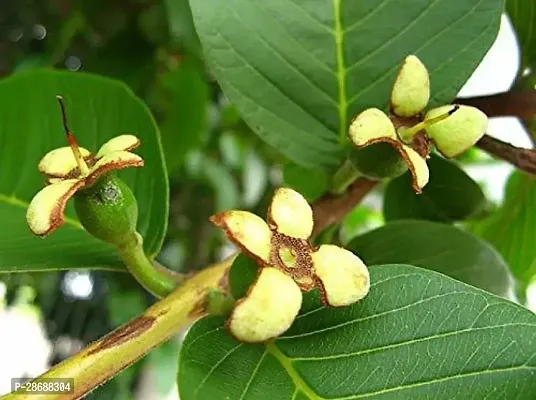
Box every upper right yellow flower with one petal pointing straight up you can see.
[348,55,488,193]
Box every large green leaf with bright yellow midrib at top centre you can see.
[190,0,503,170]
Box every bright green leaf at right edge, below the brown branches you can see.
[471,171,536,282]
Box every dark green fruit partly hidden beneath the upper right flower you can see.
[349,143,408,180]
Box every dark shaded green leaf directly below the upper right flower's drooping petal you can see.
[383,155,486,222]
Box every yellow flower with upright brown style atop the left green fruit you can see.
[26,96,143,237]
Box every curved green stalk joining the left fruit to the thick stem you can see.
[116,233,179,297]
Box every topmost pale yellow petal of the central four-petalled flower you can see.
[268,188,314,239]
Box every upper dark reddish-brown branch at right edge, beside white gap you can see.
[455,90,536,120]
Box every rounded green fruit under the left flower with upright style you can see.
[74,175,138,246]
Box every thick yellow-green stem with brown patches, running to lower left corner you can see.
[0,255,235,400]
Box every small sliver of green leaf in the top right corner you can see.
[506,0,536,70]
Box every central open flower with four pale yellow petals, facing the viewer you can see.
[210,188,370,342]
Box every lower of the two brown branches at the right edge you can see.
[476,135,536,175]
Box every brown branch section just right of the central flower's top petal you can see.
[313,178,378,235]
